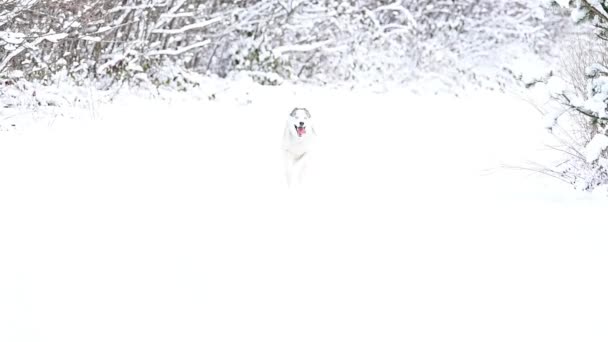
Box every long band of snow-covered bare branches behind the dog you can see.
[0,0,559,86]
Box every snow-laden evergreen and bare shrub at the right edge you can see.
[550,0,608,190]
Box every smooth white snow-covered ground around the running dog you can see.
[0,84,608,342]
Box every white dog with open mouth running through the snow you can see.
[283,108,316,186]
